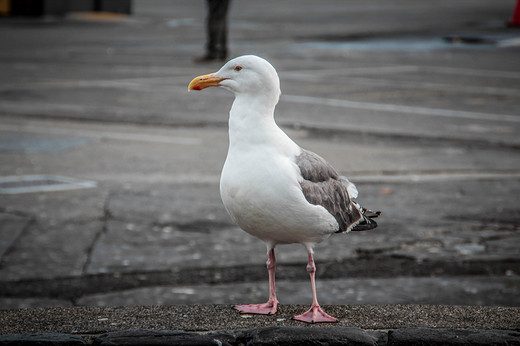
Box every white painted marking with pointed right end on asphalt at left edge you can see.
[0,175,97,194]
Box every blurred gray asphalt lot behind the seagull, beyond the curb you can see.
[0,0,520,309]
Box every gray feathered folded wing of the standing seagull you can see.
[296,150,364,233]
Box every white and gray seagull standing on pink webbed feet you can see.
[188,55,380,323]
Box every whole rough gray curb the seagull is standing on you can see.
[0,305,520,346]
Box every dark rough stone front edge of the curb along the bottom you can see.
[0,327,520,346]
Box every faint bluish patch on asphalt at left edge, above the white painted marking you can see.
[0,134,92,153]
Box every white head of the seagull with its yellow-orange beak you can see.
[188,55,280,101]
